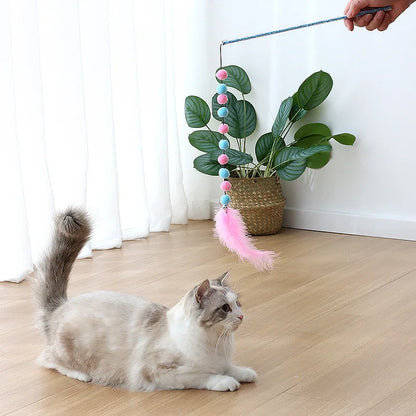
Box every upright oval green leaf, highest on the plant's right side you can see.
[297,71,333,110]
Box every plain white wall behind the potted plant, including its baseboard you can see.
[199,0,416,240]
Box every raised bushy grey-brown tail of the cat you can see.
[35,208,91,334]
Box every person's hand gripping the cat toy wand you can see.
[344,0,415,31]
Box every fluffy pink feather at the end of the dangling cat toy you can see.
[215,208,276,271]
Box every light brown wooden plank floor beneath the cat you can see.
[0,221,416,416]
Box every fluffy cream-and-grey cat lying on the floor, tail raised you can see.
[36,209,256,391]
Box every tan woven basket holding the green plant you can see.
[228,176,286,235]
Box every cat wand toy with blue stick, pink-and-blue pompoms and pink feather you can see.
[215,6,392,271]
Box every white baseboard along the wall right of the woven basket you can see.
[283,207,416,241]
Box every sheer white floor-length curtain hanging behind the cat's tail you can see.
[0,0,216,282]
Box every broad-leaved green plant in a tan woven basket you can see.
[185,65,355,235]
